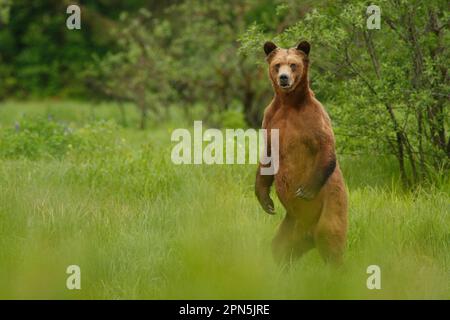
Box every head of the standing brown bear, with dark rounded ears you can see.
[264,41,310,92]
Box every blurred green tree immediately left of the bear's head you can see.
[163,0,268,127]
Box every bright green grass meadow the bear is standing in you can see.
[0,102,450,299]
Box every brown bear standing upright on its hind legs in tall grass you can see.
[255,41,347,264]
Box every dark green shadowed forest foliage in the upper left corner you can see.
[0,0,171,98]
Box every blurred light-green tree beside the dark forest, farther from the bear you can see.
[84,9,173,129]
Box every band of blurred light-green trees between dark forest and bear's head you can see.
[89,0,290,127]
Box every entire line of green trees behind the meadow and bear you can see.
[0,0,450,186]
